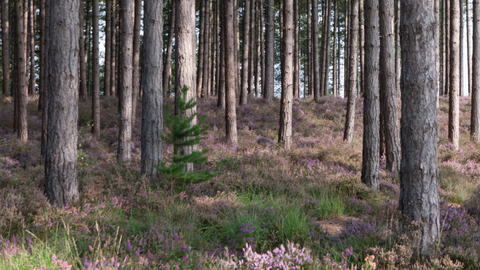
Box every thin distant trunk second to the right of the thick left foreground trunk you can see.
[103,0,112,97]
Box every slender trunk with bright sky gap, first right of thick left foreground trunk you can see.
[92,0,100,139]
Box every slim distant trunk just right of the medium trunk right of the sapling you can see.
[240,0,251,105]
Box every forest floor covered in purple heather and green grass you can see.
[0,97,480,269]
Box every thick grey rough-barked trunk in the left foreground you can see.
[45,0,80,207]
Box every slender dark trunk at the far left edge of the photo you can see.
[2,0,10,97]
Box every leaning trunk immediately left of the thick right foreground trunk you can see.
[379,0,400,174]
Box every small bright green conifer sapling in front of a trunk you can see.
[156,86,215,185]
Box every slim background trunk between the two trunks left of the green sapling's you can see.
[132,0,141,126]
